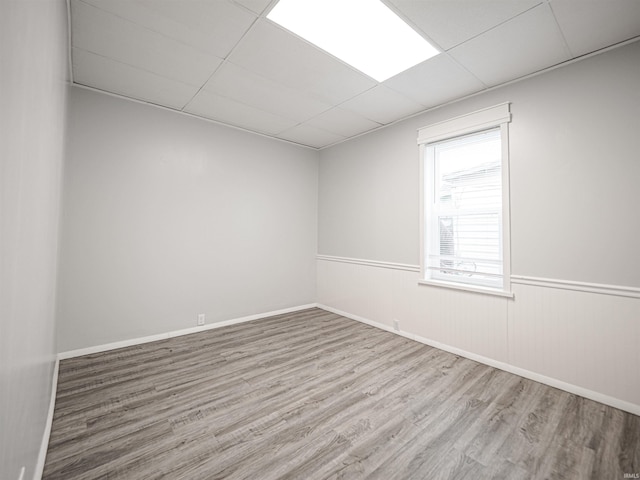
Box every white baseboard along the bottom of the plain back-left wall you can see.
[58,303,318,360]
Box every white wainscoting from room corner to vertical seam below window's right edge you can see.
[318,260,509,362]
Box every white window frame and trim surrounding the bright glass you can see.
[418,102,513,297]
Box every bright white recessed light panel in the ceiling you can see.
[267,0,439,82]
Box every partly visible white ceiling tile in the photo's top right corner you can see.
[550,0,640,56]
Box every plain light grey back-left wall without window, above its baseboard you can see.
[58,87,319,351]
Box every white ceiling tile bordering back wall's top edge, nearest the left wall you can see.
[73,48,198,110]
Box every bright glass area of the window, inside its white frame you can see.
[426,129,502,287]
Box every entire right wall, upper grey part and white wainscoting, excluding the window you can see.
[318,42,640,413]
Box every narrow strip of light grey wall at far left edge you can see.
[0,0,67,480]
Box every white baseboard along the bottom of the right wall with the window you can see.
[317,304,640,416]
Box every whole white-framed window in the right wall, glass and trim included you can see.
[418,104,511,295]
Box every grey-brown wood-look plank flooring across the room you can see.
[44,309,640,480]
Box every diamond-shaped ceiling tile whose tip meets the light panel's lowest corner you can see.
[340,85,424,124]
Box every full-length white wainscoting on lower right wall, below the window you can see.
[317,256,640,415]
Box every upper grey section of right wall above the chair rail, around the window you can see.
[318,42,640,287]
